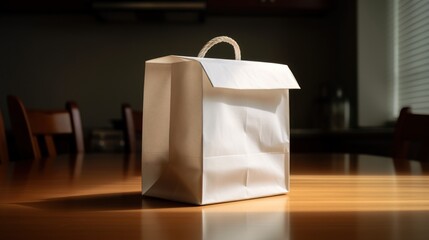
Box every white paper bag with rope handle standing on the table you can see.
[142,37,299,205]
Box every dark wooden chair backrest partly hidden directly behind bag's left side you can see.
[122,103,143,153]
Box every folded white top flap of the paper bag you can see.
[183,57,300,89]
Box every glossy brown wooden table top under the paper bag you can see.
[0,154,429,240]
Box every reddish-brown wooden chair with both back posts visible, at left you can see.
[7,96,85,159]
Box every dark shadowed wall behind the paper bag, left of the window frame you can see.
[0,1,356,129]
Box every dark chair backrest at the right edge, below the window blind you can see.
[393,107,429,160]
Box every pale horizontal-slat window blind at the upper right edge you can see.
[394,0,429,114]
